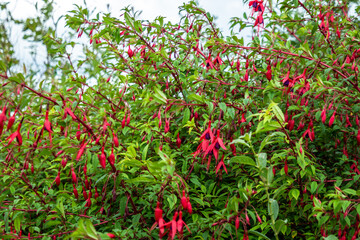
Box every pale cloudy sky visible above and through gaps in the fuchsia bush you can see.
[0,0,250,69]
